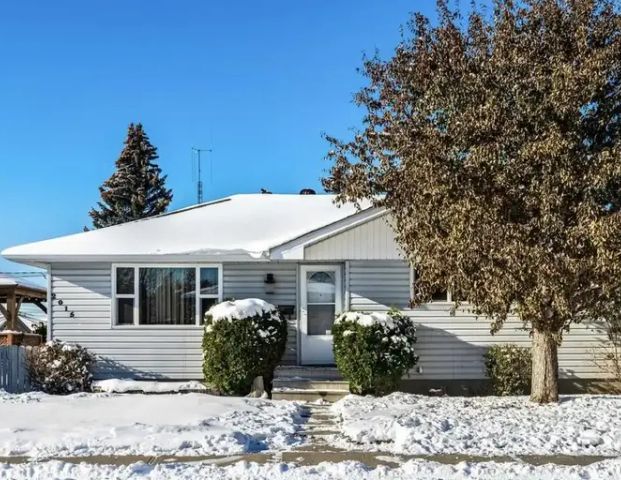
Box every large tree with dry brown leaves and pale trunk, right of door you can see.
[324,0,621,403]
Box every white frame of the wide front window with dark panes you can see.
[110,263,223,329]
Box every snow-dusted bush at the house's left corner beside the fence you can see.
[27,341,93,395]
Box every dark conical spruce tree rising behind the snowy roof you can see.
[89,123,172,228]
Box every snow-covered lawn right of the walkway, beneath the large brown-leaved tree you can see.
[331,393,621,456]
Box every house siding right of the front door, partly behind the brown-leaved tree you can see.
[349,261,609,380]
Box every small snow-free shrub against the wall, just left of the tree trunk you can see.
[483,344,532,395]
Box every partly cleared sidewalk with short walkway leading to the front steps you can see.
[0,404,616,468]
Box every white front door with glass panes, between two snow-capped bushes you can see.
[300,265,342,365]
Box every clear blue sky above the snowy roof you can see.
[0,0,435,272]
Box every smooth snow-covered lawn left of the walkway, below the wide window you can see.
[0,391,301,458]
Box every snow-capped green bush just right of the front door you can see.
[332,310,418,395]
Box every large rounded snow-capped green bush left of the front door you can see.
[203,298,287,395]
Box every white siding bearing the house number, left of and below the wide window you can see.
[51,263,202,379]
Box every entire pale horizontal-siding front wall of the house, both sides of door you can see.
[51,260,608,380]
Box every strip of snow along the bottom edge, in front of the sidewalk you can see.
[0,460,621,480]
